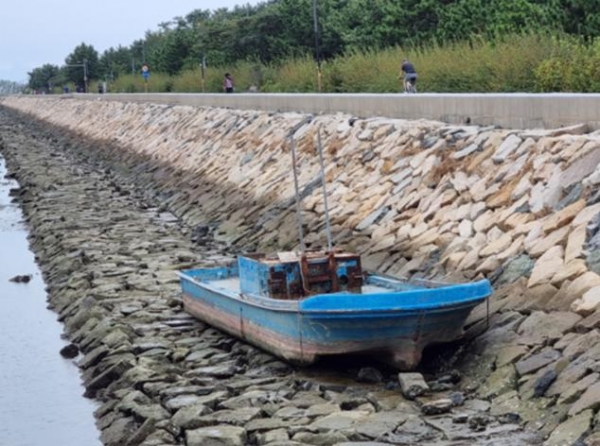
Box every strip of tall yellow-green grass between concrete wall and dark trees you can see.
[105,34,600,93]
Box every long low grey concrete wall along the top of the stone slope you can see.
[82,93,600,130]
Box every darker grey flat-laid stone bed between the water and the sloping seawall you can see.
[0,109,539,446]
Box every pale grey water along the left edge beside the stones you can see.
[0,157,101,446]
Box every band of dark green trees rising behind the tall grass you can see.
[21,0,600,88]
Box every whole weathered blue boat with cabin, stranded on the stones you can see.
[179,252,492,370]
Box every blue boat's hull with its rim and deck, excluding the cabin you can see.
[179,266,492,370]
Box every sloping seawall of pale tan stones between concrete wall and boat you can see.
[2,98,600,444]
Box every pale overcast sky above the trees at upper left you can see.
[0,0,259,83]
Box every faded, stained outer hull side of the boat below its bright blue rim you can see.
[180,274,489,370]
